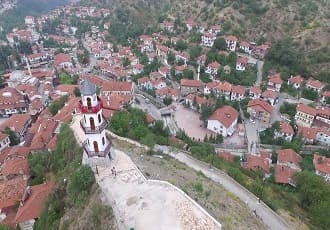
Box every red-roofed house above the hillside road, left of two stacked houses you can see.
[244,152,272,174]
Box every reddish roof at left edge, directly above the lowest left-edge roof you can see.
[1,157,30,176]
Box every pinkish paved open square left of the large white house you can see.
[174,104,211,140]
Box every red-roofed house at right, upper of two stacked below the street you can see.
[277,149,302,171]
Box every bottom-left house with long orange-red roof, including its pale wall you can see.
[15,183,53,229]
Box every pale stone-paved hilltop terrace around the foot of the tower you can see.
[71,116,221,230]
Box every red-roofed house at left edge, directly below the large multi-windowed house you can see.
[0,114,32,141]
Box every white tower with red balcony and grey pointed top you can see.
[79,78,111,158]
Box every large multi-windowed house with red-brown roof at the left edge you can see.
[0,87,29,116]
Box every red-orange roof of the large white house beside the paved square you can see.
[208,105,239,128]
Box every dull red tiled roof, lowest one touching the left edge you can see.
[0,176,27,209]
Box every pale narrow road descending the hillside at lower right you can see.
[156,146,291,230]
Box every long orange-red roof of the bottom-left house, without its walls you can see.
[15,183,53,224]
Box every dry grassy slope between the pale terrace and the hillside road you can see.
[113,140,266,230]
